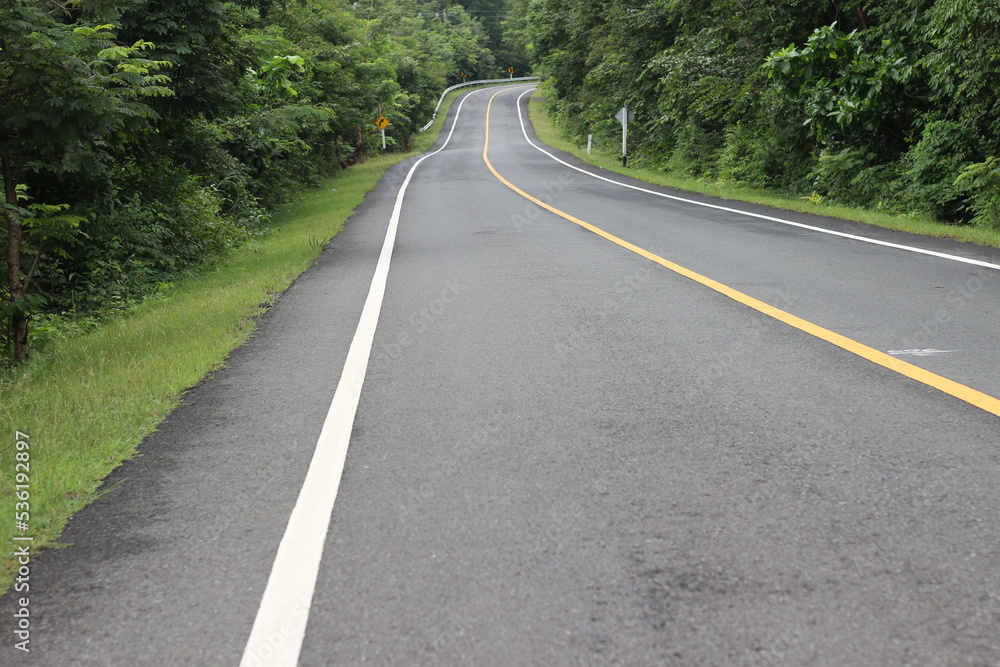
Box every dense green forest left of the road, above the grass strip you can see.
[0,0,527,362]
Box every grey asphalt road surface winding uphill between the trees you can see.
[0,87,1000,667]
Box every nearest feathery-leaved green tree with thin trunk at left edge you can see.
[0,0,171,361]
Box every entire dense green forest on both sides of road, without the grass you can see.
[0,0,1000,360]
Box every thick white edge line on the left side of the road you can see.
[240,91,481,667]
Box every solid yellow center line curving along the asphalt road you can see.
[483,91,1000,416]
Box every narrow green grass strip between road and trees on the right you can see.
[529,92,1000,248]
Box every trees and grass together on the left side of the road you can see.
[0,0,524,591]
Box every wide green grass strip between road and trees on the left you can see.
[0,85,472,593]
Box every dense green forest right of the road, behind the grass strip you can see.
[532,0,1000,227]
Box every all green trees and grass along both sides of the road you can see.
[0,0,1000,590]
